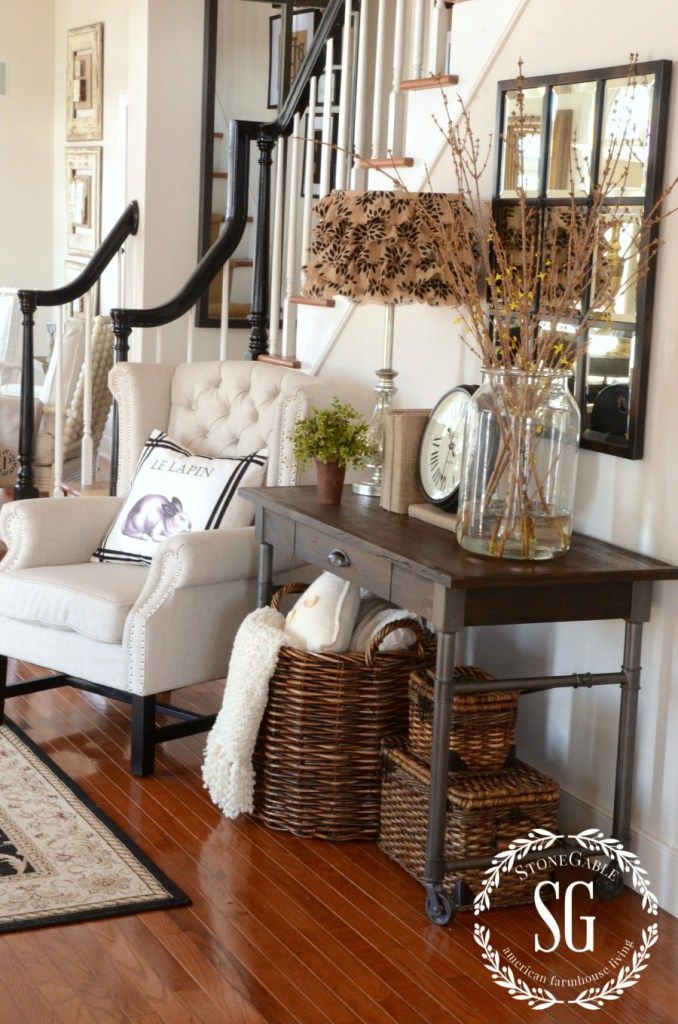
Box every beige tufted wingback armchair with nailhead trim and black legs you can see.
[0,361,345,775]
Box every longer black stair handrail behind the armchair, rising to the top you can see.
[111,0,345,348]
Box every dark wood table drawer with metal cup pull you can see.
[294,523,391,598]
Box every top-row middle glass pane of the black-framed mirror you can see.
[547,82,597,199]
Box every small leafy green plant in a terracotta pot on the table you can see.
[291,395,371,505]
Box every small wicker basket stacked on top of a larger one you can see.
[408,666,518,771]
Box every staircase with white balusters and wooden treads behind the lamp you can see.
[201,0,529,374]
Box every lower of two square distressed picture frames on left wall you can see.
[66,146,101,256]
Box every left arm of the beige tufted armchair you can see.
[0,497,122,572]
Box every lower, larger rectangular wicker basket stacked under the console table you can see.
[379,743,558,906]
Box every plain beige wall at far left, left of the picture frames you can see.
[0,0,54,351]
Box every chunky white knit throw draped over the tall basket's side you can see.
[203,608,297,818]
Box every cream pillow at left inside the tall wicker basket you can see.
[285,572,361,654]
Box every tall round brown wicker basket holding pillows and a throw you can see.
[254,584,432,840]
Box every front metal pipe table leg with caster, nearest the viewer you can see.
[424,633,456,925]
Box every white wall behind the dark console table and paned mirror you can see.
[323,0,678,914]
